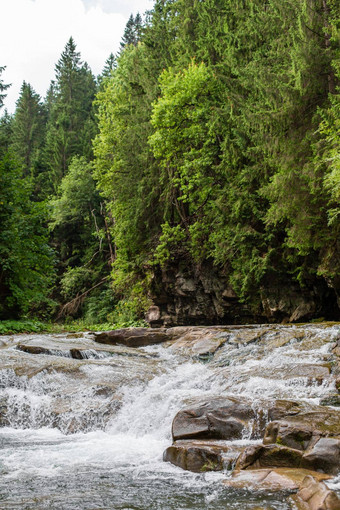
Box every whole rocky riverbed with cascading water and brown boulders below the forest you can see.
[0,324,340,510]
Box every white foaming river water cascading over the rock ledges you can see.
[0,326,339,510]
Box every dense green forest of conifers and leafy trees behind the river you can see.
[0,0,340,324]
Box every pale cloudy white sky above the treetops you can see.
[0,0,153,113]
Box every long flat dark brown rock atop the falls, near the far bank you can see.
[94,328,171,347]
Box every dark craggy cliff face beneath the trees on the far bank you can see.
[147,264,340,327]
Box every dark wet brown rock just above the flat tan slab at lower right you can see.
[236,445,303,469]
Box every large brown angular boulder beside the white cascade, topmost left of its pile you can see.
[172,397,255,440]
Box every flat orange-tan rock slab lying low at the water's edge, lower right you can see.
[224,468,330,491]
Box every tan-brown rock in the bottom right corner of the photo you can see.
[292,475,340,510]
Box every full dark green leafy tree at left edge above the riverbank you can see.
[0,154,55,317]
